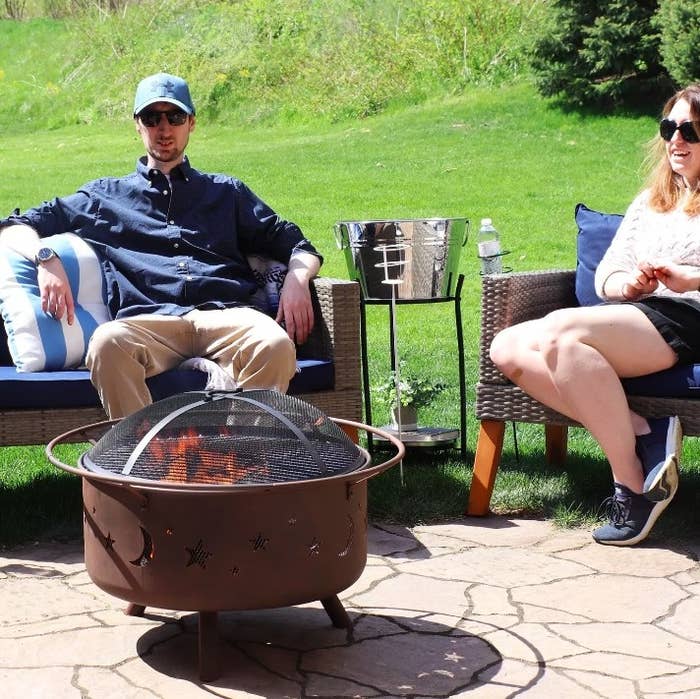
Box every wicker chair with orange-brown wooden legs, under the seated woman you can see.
[467,270,700,515]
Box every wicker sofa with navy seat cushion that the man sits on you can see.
[0,277,362,446]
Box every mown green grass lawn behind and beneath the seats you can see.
[0,84,700,543]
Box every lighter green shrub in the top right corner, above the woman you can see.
[654,0,700,86]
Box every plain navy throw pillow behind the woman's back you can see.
[574,204,623,306]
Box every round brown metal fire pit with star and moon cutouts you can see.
[46,391,405,680]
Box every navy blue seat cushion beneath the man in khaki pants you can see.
[0,359,335,410]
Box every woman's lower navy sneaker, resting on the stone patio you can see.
[593,483,671,546]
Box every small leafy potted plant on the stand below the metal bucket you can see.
[372,361,445,431]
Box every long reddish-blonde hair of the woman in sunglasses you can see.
[647,84,700,216]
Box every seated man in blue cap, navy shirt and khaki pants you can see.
[0,73,322,419]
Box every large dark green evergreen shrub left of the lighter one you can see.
[531,0,669,109]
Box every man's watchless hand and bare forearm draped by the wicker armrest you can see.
[275,253,320,345]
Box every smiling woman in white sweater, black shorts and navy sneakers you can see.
[491,85,700,546]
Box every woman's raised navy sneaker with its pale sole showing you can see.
[636,417,683,502]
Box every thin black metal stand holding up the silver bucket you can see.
[360,274,467,457]
